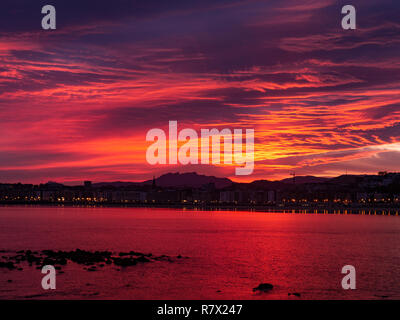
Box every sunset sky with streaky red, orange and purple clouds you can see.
[0,0,400,184]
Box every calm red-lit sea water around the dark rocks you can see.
[0,206,400,299]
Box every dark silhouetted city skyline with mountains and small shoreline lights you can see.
[0,172,400,209]
